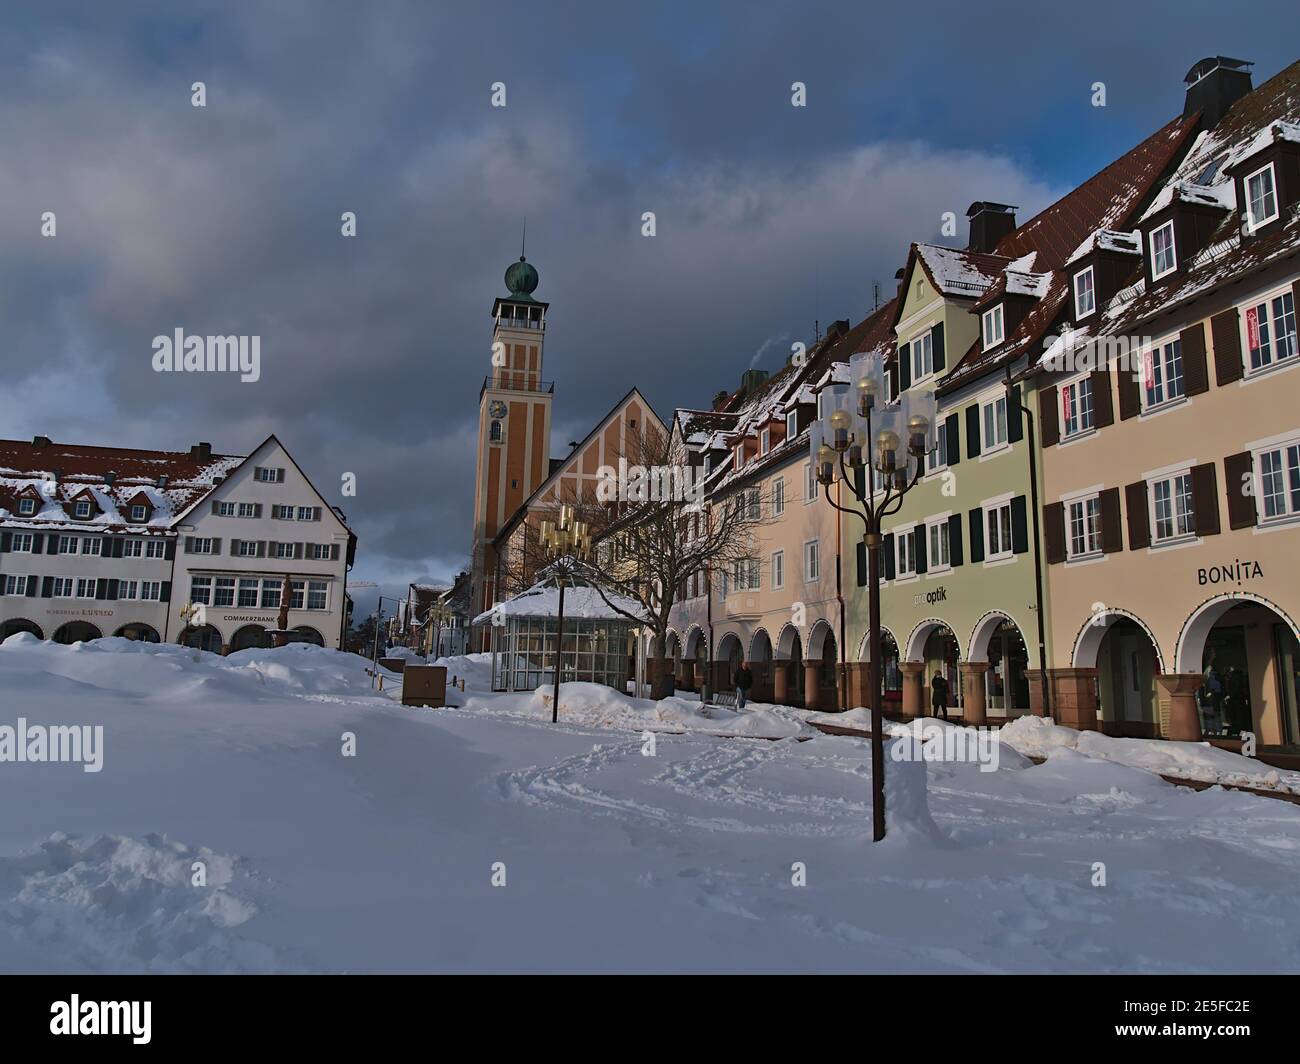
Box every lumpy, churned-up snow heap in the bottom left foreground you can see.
[0,832,283,973]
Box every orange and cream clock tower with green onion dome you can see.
[471,255,555,634]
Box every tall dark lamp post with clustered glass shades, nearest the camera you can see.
[810,354,936,842]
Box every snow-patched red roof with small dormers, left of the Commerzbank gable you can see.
[0,437,244,532]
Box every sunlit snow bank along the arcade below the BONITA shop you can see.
[1002,717,1300,793]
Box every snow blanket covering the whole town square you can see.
[0,636,1300,972]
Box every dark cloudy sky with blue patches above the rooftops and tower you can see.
[0,0,1300,613]
